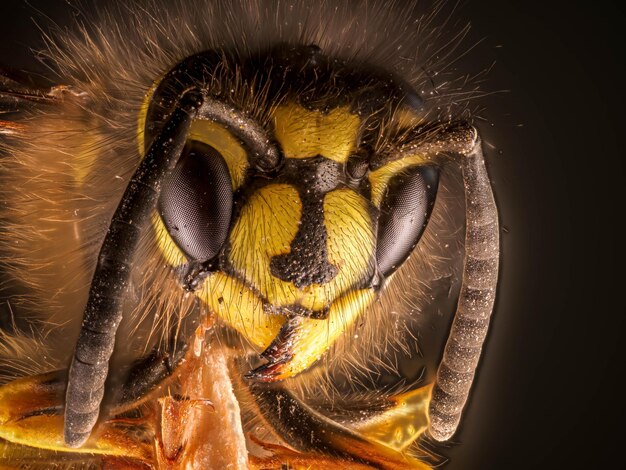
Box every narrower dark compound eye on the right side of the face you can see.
[376,166,439,276]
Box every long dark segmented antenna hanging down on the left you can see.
[64,90,203,447]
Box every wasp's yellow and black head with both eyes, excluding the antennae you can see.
[146,45,438,380]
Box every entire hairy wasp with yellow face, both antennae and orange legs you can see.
[0,0,499,469]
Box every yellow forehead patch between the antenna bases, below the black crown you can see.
[274,103,361,163]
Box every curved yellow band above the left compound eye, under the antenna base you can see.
[188,119,249,190]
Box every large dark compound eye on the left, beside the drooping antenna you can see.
[159,141,233,261]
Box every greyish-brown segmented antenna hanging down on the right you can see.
[429,125,500,441]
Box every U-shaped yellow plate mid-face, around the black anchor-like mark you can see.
[229,184,374,311]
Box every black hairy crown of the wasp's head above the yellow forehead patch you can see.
[145,44,423,147]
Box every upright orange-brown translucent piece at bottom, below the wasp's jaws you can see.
[157,335,248,470]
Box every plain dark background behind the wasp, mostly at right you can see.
[0,0,626,470]
